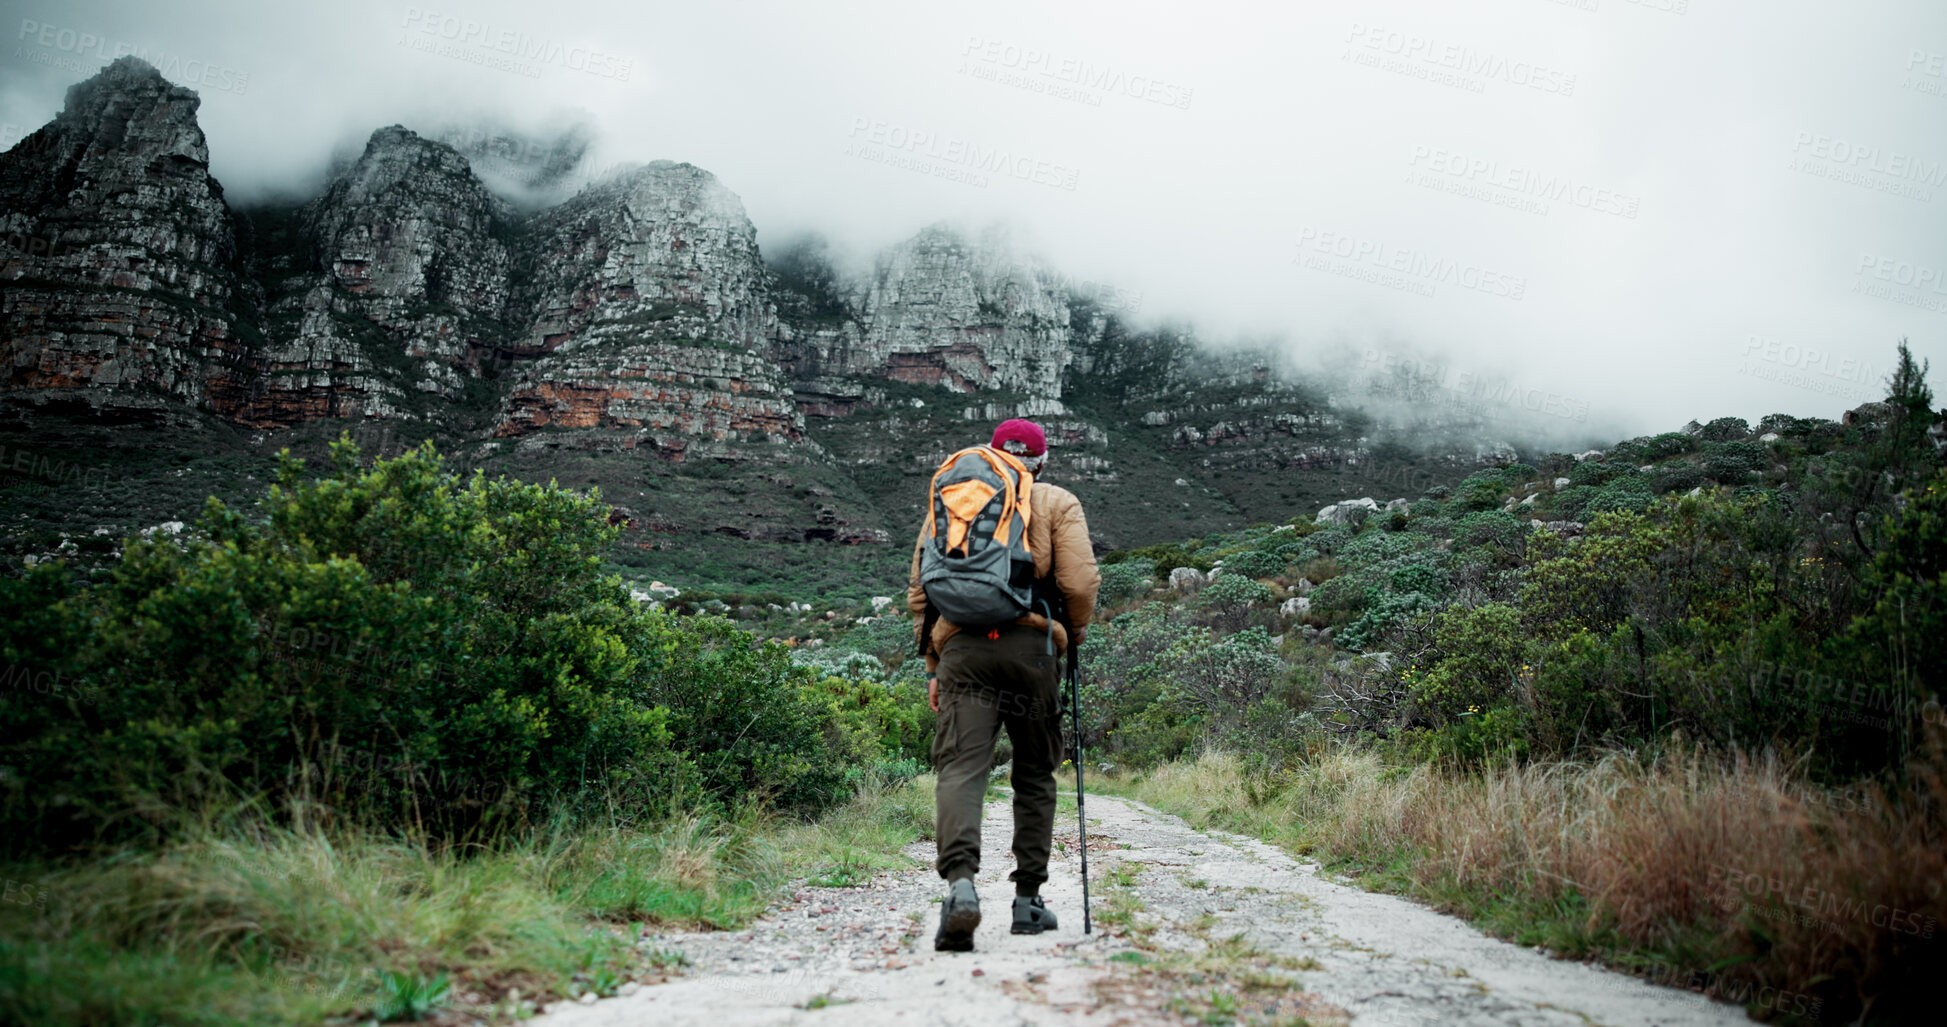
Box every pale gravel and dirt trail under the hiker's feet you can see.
[537,797,1748,1027]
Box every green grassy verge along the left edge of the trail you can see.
[0,780,933,1027]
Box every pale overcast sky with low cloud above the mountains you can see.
[0,0,1947,435]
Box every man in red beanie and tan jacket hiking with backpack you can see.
[905,419,1102,951]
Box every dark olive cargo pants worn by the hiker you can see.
[933,624,1061,887]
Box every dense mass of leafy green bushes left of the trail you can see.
[0,440,860,850]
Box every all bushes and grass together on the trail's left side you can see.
[0,440,931,1023]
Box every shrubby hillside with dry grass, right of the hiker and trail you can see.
[1084,345,1947,1023]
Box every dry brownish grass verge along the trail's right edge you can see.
[1090,750,1947,1023]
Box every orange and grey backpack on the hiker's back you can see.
[919,446,1034,631]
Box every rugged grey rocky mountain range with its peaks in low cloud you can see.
[0,58,1557,596]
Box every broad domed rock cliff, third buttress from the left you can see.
[495,160,804,458]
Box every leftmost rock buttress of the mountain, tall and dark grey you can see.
[0,57,251,413]
